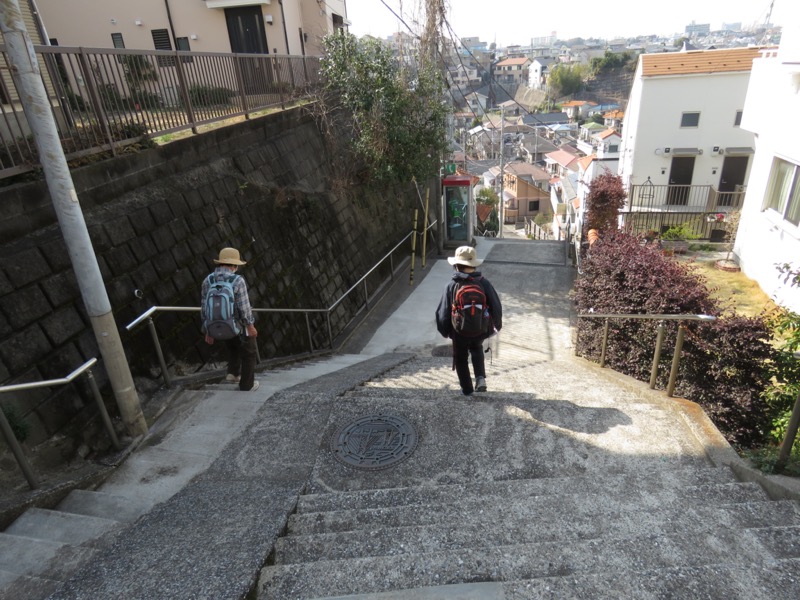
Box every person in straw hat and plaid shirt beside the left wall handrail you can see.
[200,248,258,392]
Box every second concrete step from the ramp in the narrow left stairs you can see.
[5,508,121,545]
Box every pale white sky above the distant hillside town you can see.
[346,0,800,46]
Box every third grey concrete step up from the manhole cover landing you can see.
[275,500,800,564]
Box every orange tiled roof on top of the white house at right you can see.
[642,47,762,77]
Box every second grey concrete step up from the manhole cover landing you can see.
[287,483,769,535]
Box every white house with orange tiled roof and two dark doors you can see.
[619,48,761,239]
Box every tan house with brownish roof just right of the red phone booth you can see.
[503,162,551,223]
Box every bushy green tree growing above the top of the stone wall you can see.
[309,34,449,183]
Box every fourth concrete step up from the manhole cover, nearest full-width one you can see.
[258,527,800,599]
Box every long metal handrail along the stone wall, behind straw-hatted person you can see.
[125,220,437,387]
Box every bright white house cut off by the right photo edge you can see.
[734,24,800,313]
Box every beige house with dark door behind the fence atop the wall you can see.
[36,0,349,56]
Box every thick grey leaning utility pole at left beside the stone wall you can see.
[0,0,147,436]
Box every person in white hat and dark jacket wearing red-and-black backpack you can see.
[436,246,503,396]
